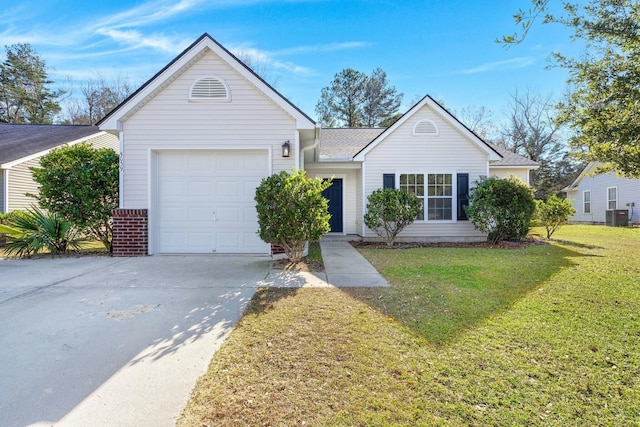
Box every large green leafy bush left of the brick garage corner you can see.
[32,143,119,252]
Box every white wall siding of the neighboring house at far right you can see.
[567,173,640,223]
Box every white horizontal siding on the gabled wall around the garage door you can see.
[122,51,298,208]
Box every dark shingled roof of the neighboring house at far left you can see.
[0,123,100,166]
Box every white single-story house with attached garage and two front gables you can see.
[98,34,537,255]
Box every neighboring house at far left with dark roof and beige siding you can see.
[0,123,119,213]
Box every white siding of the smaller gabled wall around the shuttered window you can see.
[363,106,488,241]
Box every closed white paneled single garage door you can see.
[156,150,269,254]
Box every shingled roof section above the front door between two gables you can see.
[319,128,385,161]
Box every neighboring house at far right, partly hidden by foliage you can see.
[562,162,640,224]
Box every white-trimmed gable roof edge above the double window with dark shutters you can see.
[353,95,502,161]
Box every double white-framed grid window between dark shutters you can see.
[400,173,453,221]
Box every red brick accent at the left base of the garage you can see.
[113,209,149,256]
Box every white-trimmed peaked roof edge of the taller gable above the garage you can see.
[98,33,315,130]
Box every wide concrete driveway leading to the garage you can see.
[0,255,269,426]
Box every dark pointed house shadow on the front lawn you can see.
[343,245,589,344]
